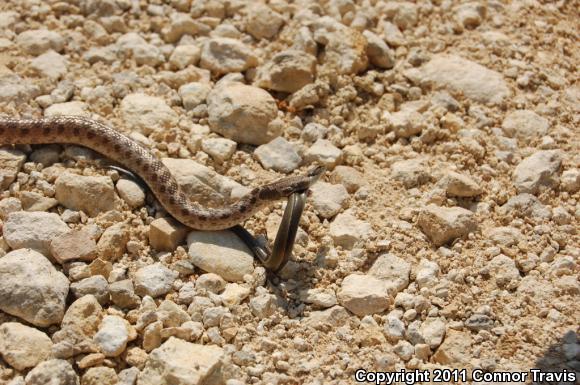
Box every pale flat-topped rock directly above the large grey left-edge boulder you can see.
[3,211,70,256]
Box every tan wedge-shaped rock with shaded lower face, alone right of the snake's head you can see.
[417,204,477,246]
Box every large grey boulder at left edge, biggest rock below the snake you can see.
[0,249,69,327]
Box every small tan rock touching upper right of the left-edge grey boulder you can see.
[50,230,97,265]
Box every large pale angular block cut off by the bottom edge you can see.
[137,337,224,385]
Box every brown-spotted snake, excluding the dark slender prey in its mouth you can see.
[0,116,323,268]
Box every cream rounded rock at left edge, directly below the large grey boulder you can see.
[0,322,52,372]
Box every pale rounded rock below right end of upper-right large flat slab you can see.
[501,110,550,144]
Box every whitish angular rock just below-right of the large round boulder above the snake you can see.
[254,136,302,174]
